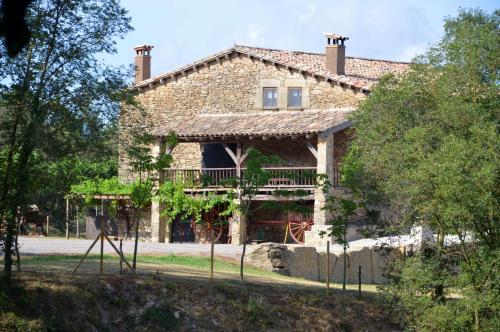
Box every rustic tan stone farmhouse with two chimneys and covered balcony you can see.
[119,34,408,244]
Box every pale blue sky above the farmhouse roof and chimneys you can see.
[105,0,500,76]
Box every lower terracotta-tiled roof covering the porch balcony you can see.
[152,108,354,141]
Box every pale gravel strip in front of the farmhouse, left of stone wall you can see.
[19,236,243,258]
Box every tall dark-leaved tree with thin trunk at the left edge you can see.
[0,0,131,280]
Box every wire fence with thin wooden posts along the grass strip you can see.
[12,224,404,295]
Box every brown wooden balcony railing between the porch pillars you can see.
[164,167,340,188]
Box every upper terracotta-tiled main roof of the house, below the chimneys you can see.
[132,45,409,92]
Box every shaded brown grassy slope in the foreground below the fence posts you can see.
[0,272,401,331]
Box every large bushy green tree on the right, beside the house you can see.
[349,10,500,329]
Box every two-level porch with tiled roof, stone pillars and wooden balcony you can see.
[151,109,351,244]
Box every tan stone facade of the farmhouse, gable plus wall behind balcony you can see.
[119,53,366,242]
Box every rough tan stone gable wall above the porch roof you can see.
[120,55,365,175]
